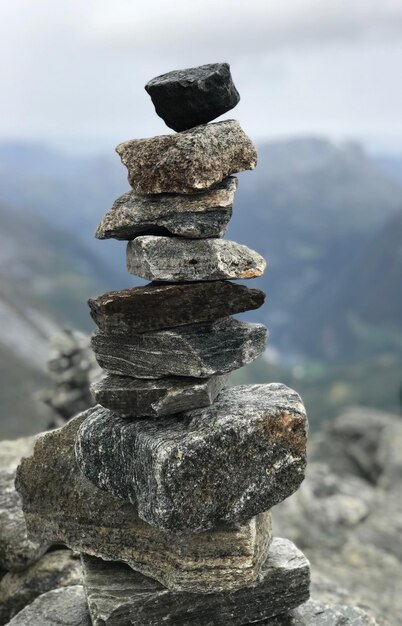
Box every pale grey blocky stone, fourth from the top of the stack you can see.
[127,235,267,282]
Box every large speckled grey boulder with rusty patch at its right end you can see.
[76,383,307,533]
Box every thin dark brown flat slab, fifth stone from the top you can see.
[86,280,265,334]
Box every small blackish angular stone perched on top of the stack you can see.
[145,63,240,131]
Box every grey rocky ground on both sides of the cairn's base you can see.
[0,394,402,626]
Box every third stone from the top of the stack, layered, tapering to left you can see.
[96,177,237,240]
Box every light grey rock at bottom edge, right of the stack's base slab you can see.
[268,599,377,626]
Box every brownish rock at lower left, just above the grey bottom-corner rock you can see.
[0,550,82,625]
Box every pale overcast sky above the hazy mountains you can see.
[0,0,402,153]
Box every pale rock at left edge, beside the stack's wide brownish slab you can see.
[0,437,46,572]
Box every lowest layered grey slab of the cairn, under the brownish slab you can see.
[83,539,310,626]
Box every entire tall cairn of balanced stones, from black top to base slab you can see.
[16,63,309,626]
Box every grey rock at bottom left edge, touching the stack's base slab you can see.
[5,585,92,626]
